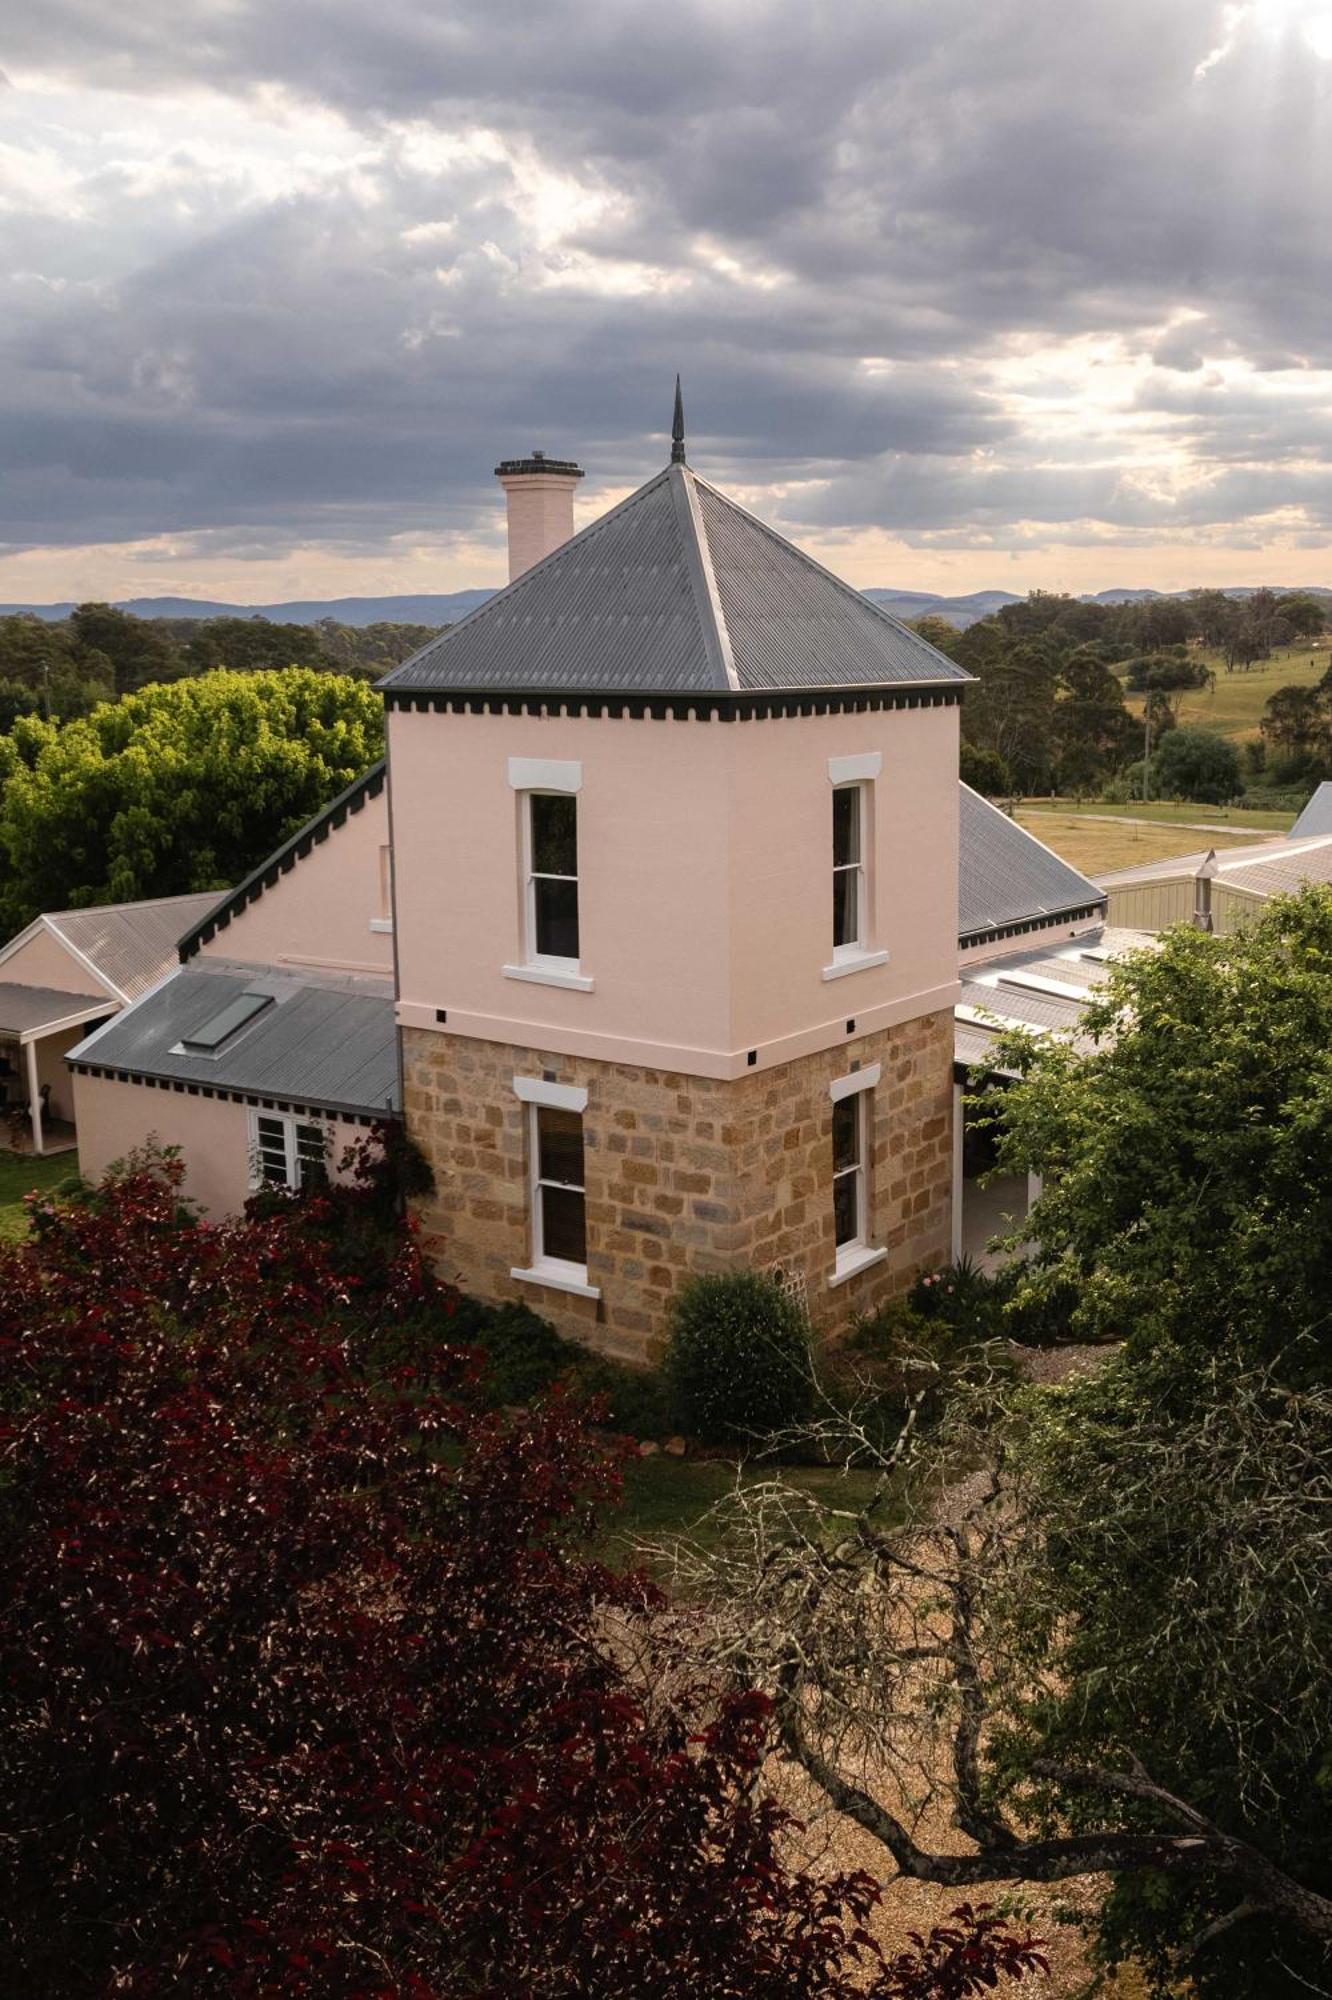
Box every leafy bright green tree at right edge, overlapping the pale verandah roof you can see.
[996,888,1332,1380]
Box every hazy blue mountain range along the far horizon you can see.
[0,584,1332,628]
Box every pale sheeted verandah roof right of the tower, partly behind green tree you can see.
[954,926,1156,1076]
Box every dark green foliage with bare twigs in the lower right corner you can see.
[1008,1322,1332,2000]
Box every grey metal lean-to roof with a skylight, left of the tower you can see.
[68,960,398,1114]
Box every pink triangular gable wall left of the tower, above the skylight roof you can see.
[204,792,394,974]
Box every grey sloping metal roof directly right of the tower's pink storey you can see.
[958,784,1106,946]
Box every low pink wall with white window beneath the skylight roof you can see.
[66,1072,364,1222]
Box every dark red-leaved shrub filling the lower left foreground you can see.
[0,1164,1038,2000]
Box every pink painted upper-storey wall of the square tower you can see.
[388,708,958,1074]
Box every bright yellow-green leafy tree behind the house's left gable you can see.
[0,668,382,932]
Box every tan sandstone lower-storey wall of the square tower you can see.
[404,1010,952,1360]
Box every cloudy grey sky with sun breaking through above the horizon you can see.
[0,0,1332,602]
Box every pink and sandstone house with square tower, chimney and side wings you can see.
[59,400,1104,1356]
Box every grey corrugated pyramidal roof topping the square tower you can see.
[380,464,970,696]
